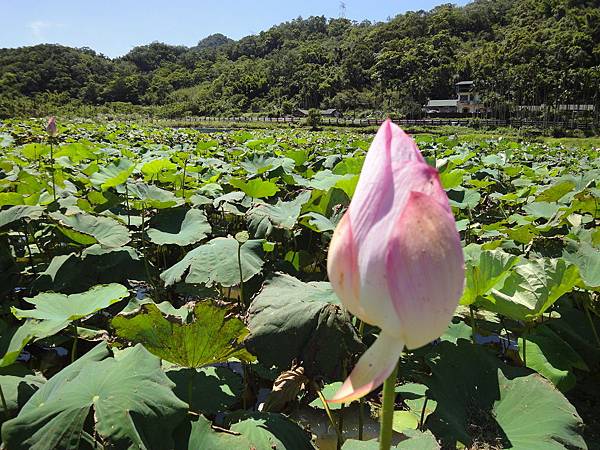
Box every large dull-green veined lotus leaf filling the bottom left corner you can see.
[2,343,187,450]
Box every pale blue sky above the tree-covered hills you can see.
[0,0,468,57]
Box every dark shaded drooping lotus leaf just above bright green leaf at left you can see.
[34,244,147,294]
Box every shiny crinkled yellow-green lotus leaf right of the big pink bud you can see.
[477,258,579,320]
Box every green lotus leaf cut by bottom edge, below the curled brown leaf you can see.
[225,412,315,450]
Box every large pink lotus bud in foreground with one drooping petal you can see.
[327,120,465,402]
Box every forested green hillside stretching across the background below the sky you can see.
[0,0,600,116]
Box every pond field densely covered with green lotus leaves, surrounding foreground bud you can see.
[0,120,600,450]
